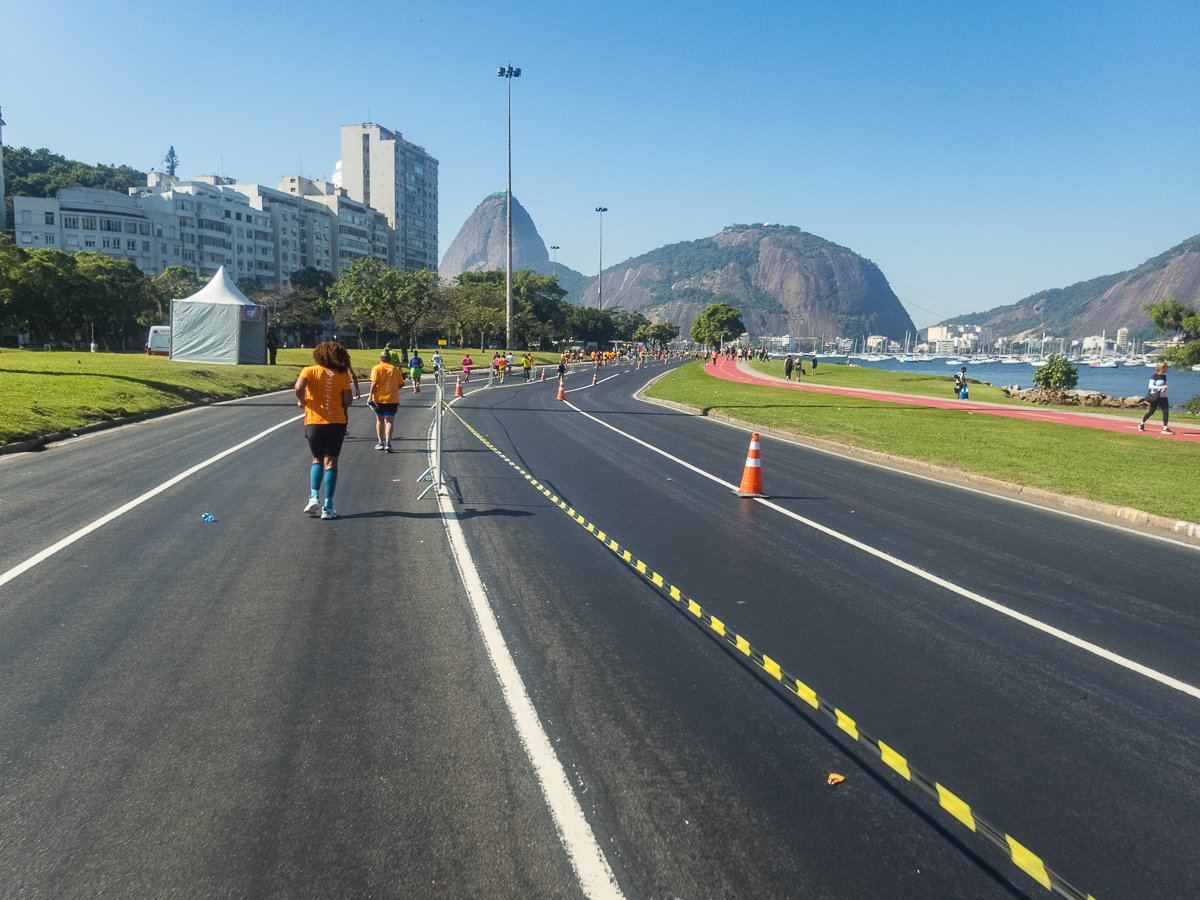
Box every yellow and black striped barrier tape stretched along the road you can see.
[446,404,1094,900]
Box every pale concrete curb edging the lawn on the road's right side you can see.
[634,372,1200,547]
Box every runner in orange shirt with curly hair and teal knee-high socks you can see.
[295,341,354,518]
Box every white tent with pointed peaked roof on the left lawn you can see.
[170,266,266,366]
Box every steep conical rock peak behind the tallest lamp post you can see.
[438,191,595,302]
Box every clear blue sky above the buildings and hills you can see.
[0,0,1200,326]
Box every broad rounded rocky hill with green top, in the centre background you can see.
[582,224,917,340]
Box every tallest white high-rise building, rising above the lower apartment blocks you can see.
[338,122,438,271]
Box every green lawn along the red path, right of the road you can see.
[648,362,1200,522]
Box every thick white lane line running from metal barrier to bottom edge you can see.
[430,428,624,900]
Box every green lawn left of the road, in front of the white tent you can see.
[0,348,571,444]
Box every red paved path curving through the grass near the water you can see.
[704,359,1200,443]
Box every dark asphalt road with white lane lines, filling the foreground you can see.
[0,367,1200,900]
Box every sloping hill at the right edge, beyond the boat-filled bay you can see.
[943,235,1200,340]
